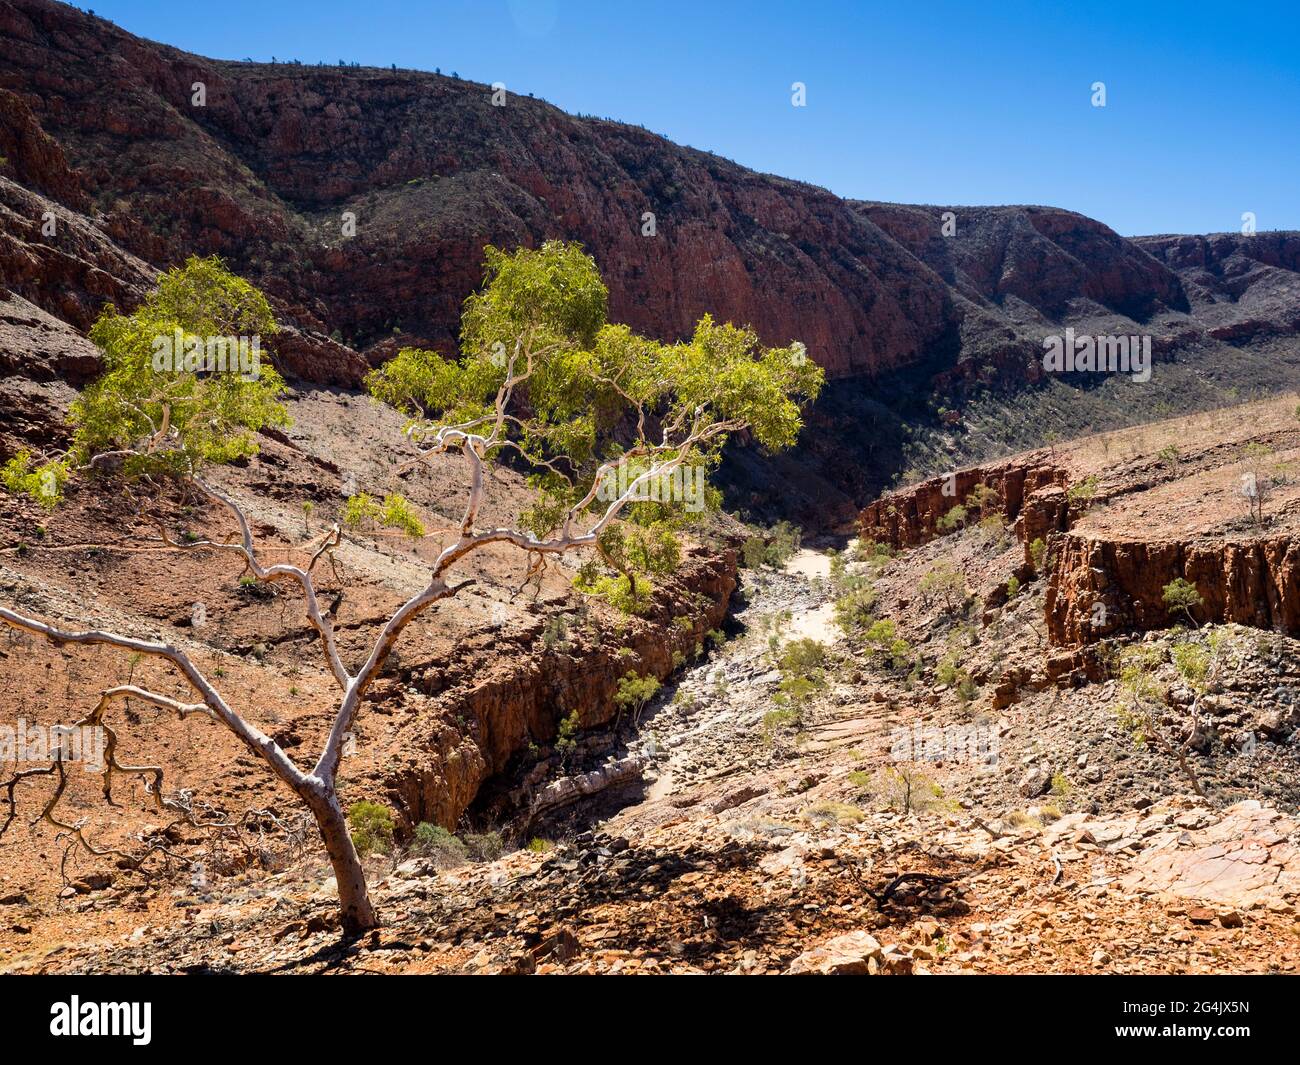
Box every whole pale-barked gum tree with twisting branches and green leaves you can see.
[0,242,823,932]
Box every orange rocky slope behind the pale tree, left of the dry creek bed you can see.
[0,382,736,956]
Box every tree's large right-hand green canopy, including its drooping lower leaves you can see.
[363,241,824,612]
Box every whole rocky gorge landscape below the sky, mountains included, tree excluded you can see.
[0,0,1300,974]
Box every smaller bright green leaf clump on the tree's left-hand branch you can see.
[70,257,289,475]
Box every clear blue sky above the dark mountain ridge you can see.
[79,0,1300,235]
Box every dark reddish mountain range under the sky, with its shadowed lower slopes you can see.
[0,0,1300,523]
